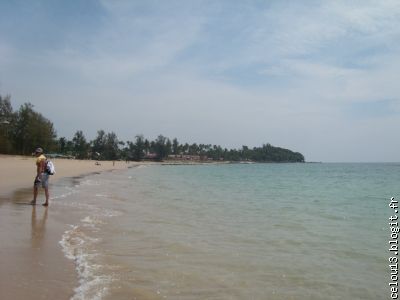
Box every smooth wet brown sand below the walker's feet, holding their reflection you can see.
[0,197,77,299]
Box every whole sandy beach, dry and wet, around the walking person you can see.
[0,155,134,300]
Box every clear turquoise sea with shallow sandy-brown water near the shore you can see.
[51,163,400,300]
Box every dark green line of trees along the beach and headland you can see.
[0,95,304,162]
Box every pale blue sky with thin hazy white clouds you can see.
[0,0,400,162]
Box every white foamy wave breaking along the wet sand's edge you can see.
[52,179,122,300]
